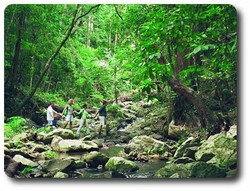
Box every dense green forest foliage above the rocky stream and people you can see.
[4,4,237,130]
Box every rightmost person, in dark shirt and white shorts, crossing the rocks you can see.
[94,101,109,135]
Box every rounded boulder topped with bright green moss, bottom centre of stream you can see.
[105,157,139,173]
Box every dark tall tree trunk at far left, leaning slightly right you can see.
[8,14,25,91]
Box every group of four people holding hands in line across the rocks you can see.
[47,99,110,136]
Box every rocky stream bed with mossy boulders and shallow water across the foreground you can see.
[4,102,237,179]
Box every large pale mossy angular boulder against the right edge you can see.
[195,132,237,168]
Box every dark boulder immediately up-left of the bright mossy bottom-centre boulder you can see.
[84,151,109,168]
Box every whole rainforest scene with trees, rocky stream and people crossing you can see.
[4,4,238,179]
